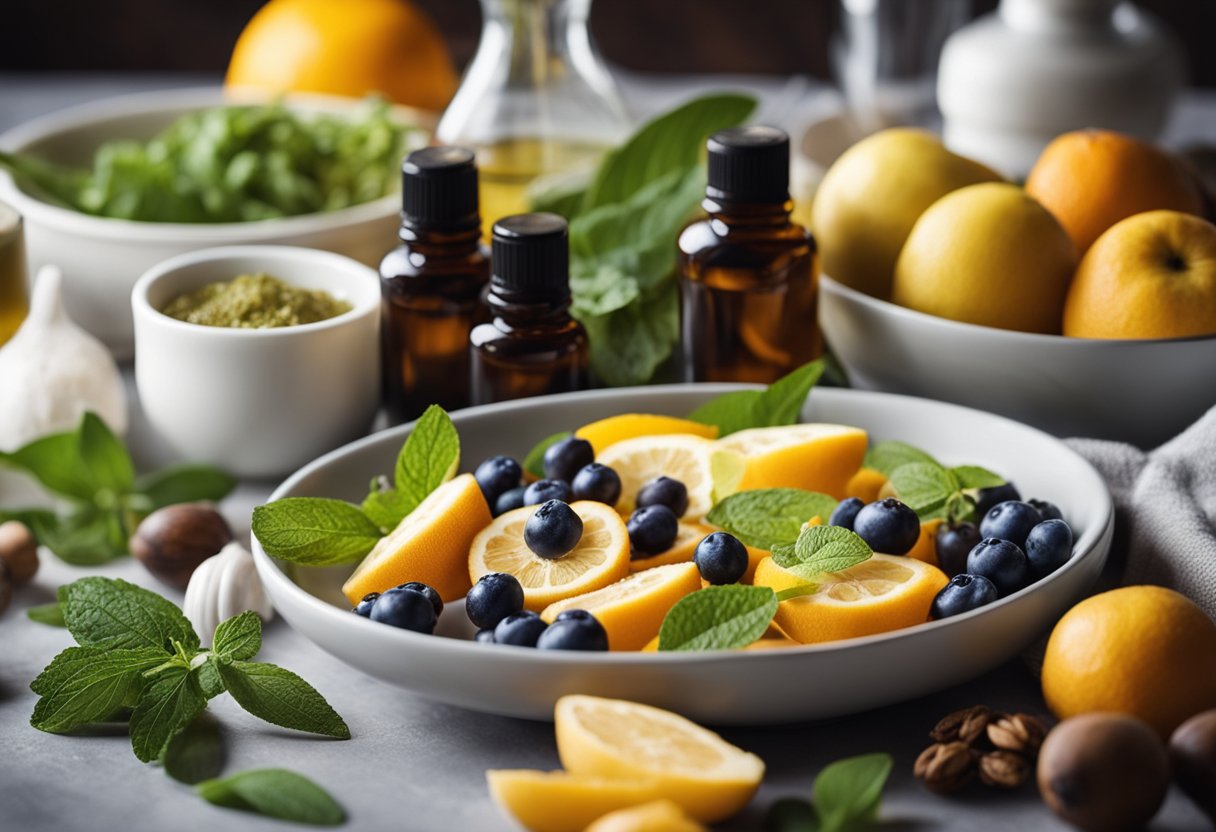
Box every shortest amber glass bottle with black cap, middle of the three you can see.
[469,214,587,404]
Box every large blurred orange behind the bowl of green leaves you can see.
[224,0,457,111]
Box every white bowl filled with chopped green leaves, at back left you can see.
[0,88,434,359]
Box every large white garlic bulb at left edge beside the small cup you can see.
[0,265,126,451]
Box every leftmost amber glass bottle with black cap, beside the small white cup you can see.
[379,147,490,422]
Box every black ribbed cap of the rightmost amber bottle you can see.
[705,125,789,203]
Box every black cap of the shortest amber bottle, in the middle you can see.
[490,214,570,300]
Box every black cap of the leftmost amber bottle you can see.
[401,147,482,231]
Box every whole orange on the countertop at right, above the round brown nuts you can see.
[1042,586,1216,738]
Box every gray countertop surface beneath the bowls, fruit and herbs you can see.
[0,74,1216,832]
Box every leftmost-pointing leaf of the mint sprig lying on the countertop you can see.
[29,647,169,733]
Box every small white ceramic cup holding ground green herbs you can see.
[130,246,381,478]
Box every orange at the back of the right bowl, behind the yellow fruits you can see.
[1026,130,1204,254]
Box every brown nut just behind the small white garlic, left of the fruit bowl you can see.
[131,504,232,589]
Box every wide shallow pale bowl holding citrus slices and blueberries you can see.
[253,384,1114,725]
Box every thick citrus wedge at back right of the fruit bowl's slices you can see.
[717,425,867,499]
